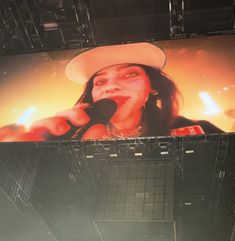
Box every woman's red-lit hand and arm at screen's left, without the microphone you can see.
[0,103,90,141]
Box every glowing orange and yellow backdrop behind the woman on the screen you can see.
[0,36,235,132]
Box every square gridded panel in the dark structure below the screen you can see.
[95,162,175,221]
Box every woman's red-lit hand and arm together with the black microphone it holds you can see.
[0,99,117,141]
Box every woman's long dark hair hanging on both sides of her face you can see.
[76,64,181,136]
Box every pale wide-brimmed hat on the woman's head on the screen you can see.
[65,42,166,84]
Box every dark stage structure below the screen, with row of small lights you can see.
[0,134,235,241]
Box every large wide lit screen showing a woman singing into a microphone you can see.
[0,36,235,141]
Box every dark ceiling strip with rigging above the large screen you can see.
[0,0,235,54]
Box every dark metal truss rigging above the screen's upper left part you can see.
[0,0,95,54]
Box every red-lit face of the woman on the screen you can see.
[92,64,151,122]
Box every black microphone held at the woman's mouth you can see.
[72,99,117,140]
